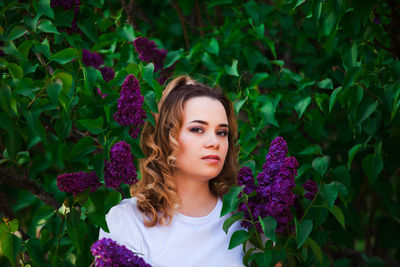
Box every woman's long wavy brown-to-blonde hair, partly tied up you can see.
[131,76,237,227]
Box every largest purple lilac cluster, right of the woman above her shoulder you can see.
[239,136,298,232]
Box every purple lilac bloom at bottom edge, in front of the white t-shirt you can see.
[90,238,151,267]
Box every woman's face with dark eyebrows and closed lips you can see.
[176,97,229,181]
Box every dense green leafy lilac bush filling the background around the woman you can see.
[0,0,400,266]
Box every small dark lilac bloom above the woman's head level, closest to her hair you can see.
[133,37,168,71]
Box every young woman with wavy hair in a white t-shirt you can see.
[100,76,243,267]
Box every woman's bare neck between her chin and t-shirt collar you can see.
[174,173,218,217]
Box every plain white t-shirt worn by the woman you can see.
[99,198,244,267]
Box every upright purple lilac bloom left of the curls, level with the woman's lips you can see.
[104,141,138,188]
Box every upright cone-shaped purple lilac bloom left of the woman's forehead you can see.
[114,74,146,138]
